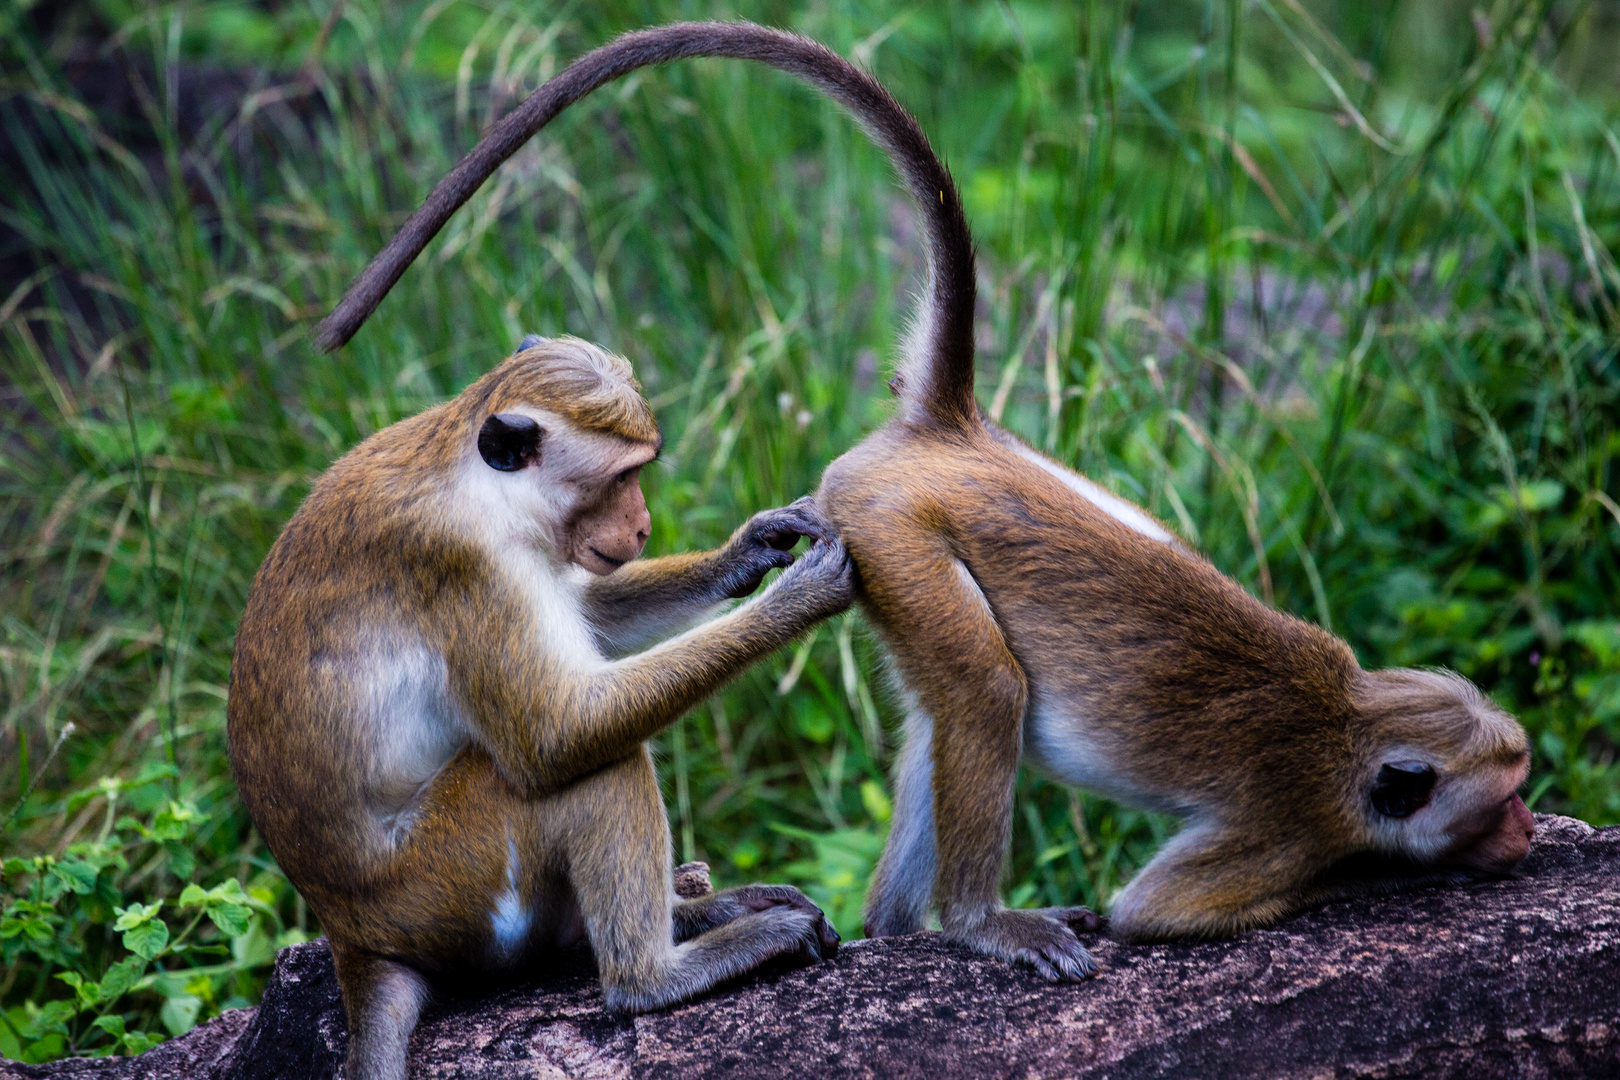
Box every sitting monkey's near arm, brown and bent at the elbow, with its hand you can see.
[447,539,854,795]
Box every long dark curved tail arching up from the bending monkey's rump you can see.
[316,23,977,427]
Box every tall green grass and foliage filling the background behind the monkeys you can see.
[0,0,1620,1059]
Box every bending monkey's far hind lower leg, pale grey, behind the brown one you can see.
[867,704,938,938]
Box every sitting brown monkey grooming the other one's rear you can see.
[228,338,852,1080]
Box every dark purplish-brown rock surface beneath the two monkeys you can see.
[0,816,1620,1080]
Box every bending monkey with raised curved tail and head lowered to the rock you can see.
[309,23,1533,980]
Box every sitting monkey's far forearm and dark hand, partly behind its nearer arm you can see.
[585,499,833,656]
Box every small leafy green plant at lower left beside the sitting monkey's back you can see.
[0,766,305,1062]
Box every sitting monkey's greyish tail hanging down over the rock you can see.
[332,941,429,1080]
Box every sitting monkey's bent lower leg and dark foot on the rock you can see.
[567,748,836,1012]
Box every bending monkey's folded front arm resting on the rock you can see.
[1108,824,1314,942]
